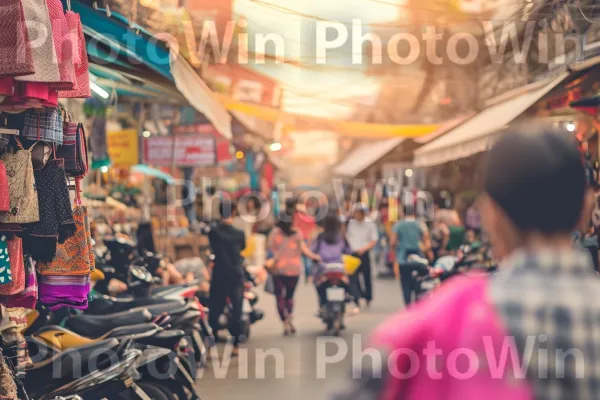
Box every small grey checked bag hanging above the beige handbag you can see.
[21,107,63,145]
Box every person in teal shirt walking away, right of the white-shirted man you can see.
[390,205,424,306]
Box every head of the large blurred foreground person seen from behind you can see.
[479,125,591,258]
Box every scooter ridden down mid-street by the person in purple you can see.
[318,263,347,336]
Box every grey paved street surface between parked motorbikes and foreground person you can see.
[198,280,402,400]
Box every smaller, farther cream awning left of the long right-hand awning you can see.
[333,138,404,178]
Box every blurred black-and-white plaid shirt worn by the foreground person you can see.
[333,249,600,400]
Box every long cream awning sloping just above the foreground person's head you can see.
[414,72,569,167]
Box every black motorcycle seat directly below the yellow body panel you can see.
[26,339,119,387]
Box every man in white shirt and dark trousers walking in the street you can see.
[346,203,379,307]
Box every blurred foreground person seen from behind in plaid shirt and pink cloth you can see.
[335,123,600,400]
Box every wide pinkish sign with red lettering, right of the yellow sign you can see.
[144,134,217,167]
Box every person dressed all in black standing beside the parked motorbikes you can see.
[208,200,246,356]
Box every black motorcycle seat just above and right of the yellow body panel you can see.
[65,309,152,338]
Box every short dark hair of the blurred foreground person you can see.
[483,125,586,234]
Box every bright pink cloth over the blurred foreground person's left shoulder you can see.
[372,276,534,400]
